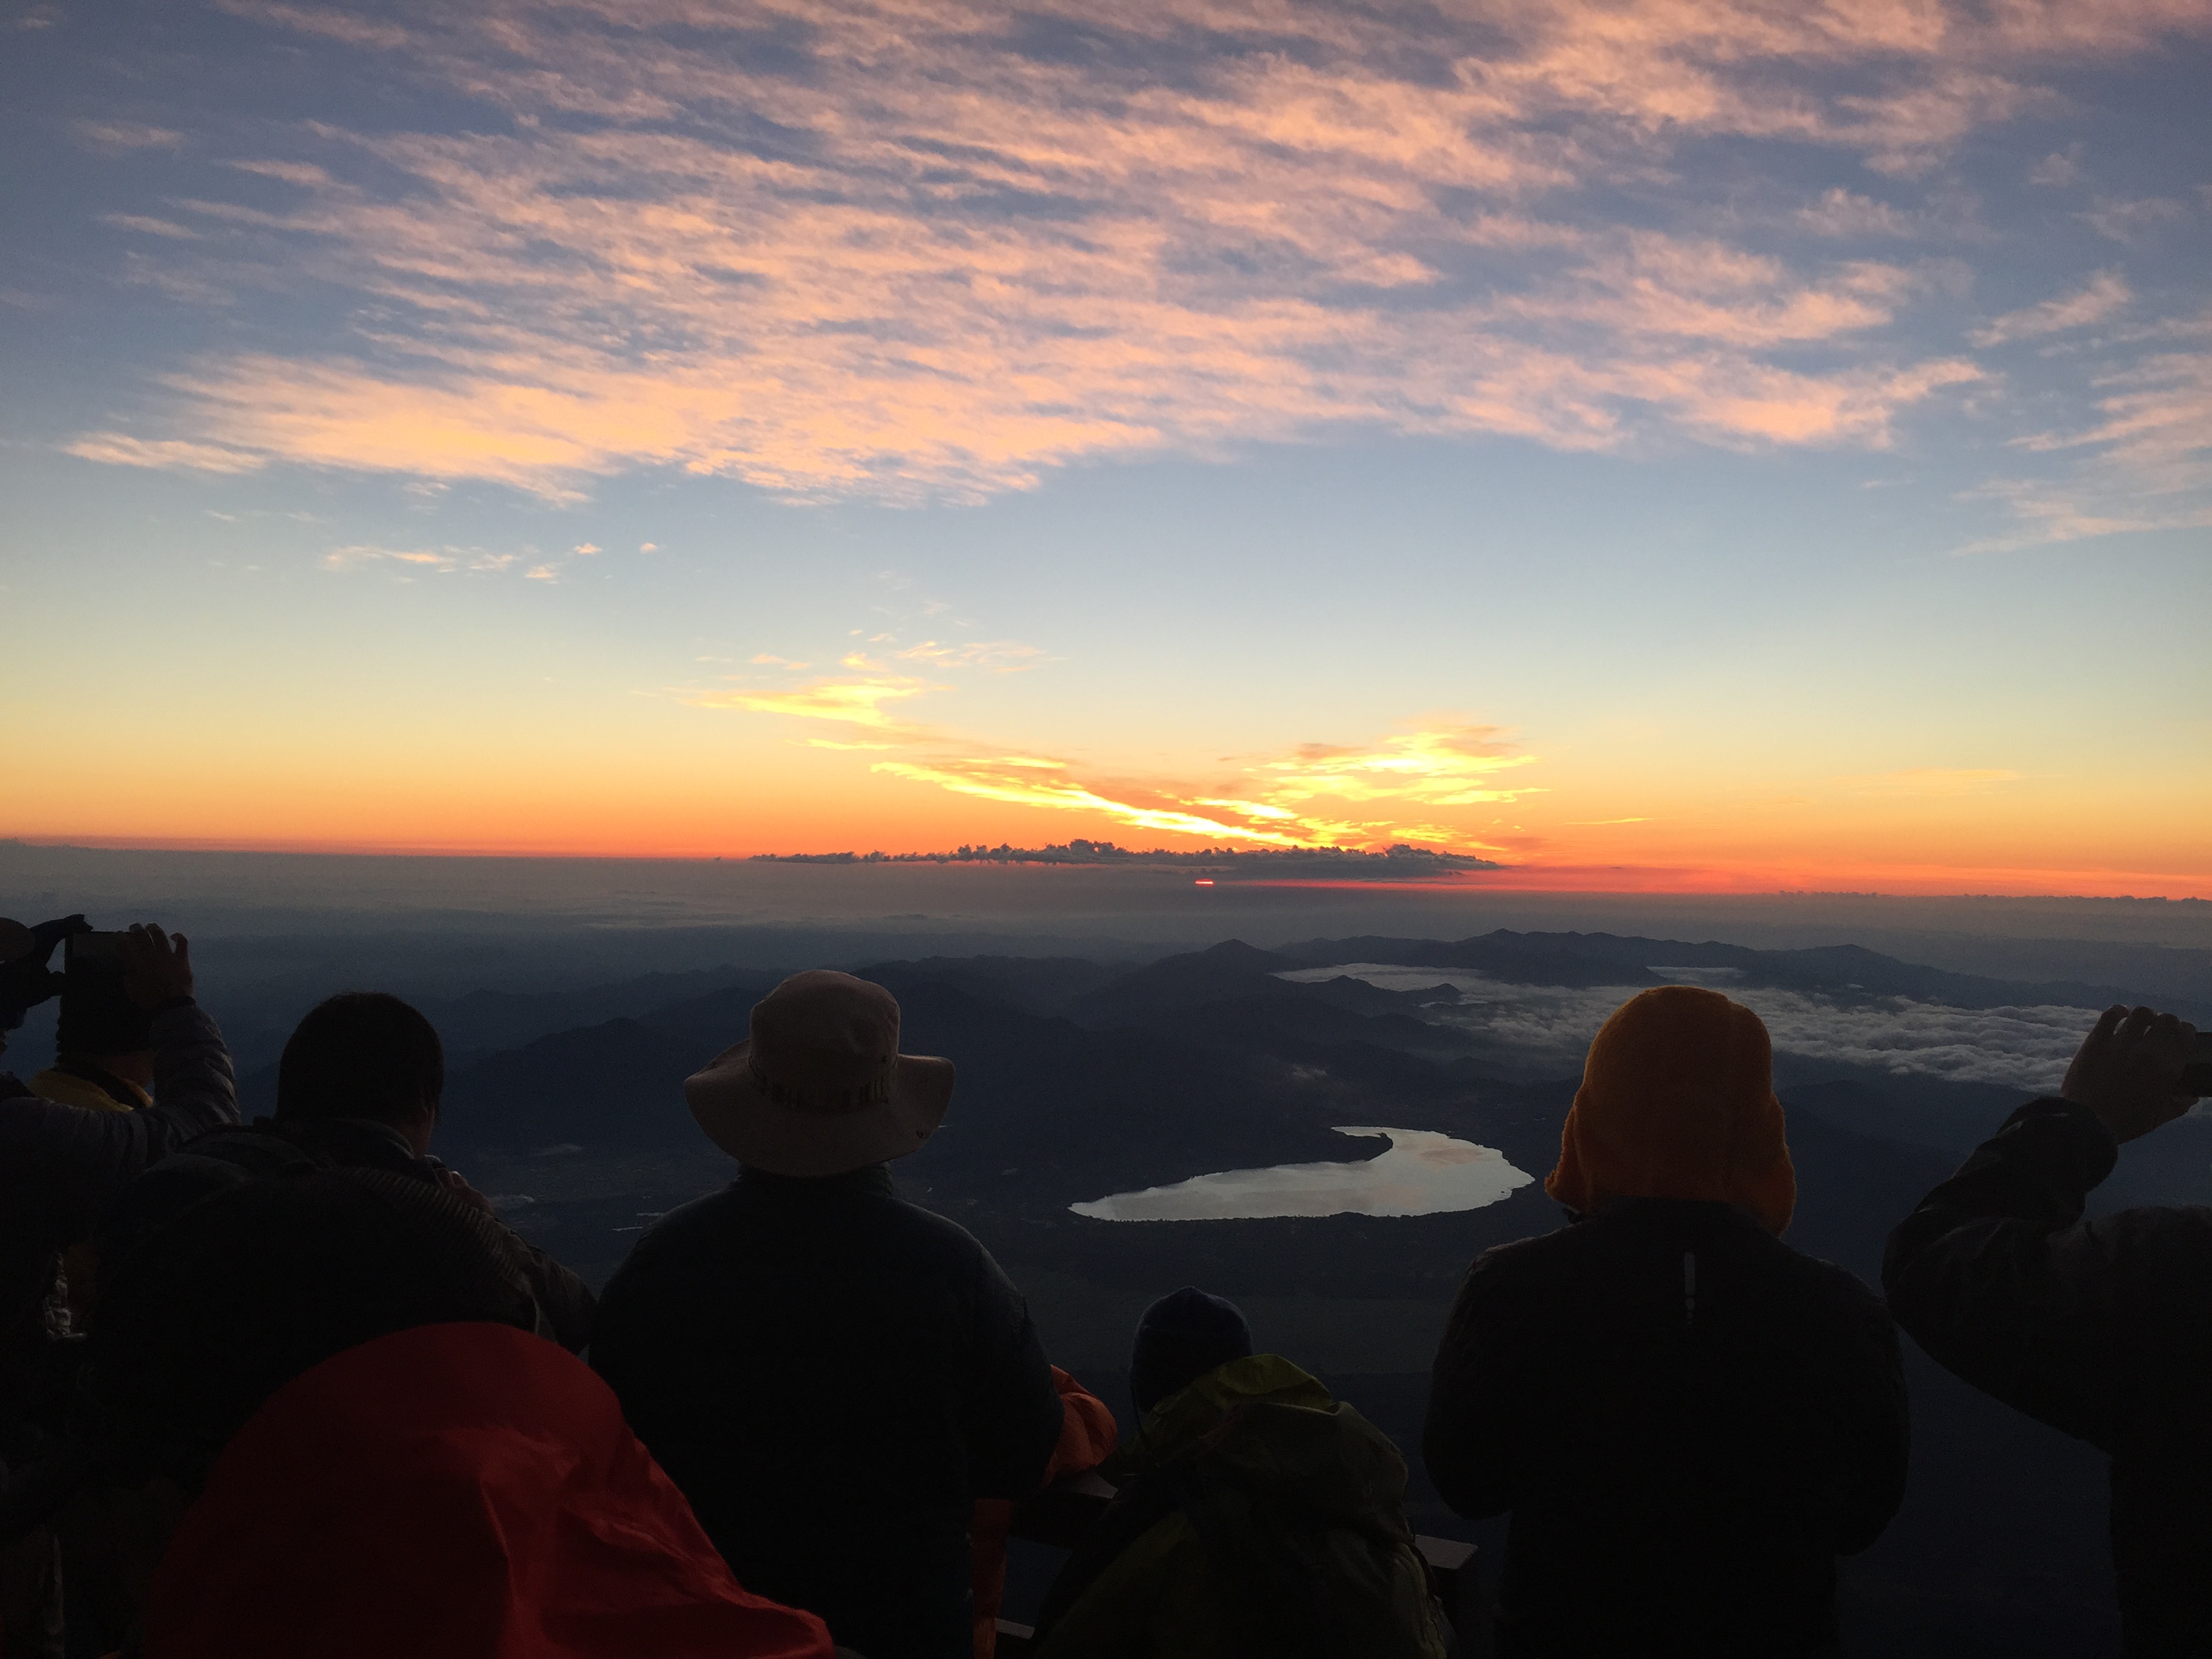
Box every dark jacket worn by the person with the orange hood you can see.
[1422,1199,1907,1659]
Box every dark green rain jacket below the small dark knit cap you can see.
[1038,1354,1444,1659]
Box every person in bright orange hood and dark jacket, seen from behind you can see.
[1422,984,1909,1659]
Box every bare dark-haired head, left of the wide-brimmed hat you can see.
[276,991,445,1153]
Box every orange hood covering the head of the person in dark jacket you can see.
[1544,984,1796,1234]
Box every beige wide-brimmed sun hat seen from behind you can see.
[684,969,954,1176]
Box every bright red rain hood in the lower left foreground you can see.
[146,1325,832,1659]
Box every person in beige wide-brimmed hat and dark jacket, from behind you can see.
[590,969,1062,1659]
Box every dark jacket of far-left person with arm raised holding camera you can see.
[0,1000,239,1431]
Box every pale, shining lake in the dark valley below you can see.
[1069,1128,1535,1221]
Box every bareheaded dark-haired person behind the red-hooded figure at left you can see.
[102,991,593,1351]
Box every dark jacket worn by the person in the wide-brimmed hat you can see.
[590,1166,1062,1659]
